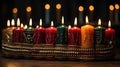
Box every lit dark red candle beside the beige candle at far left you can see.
[12,18,24,43]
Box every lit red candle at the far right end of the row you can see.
[105,21,115,45]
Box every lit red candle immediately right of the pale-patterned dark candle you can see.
[34,19,45,44]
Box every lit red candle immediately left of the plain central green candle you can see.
[45,21,57,45]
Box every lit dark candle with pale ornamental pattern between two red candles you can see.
[25,18,34,44]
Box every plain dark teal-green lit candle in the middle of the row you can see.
[56,16,68,46]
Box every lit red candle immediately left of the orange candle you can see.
[68,18,81,46]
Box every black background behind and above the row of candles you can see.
[0,0,120,47]
